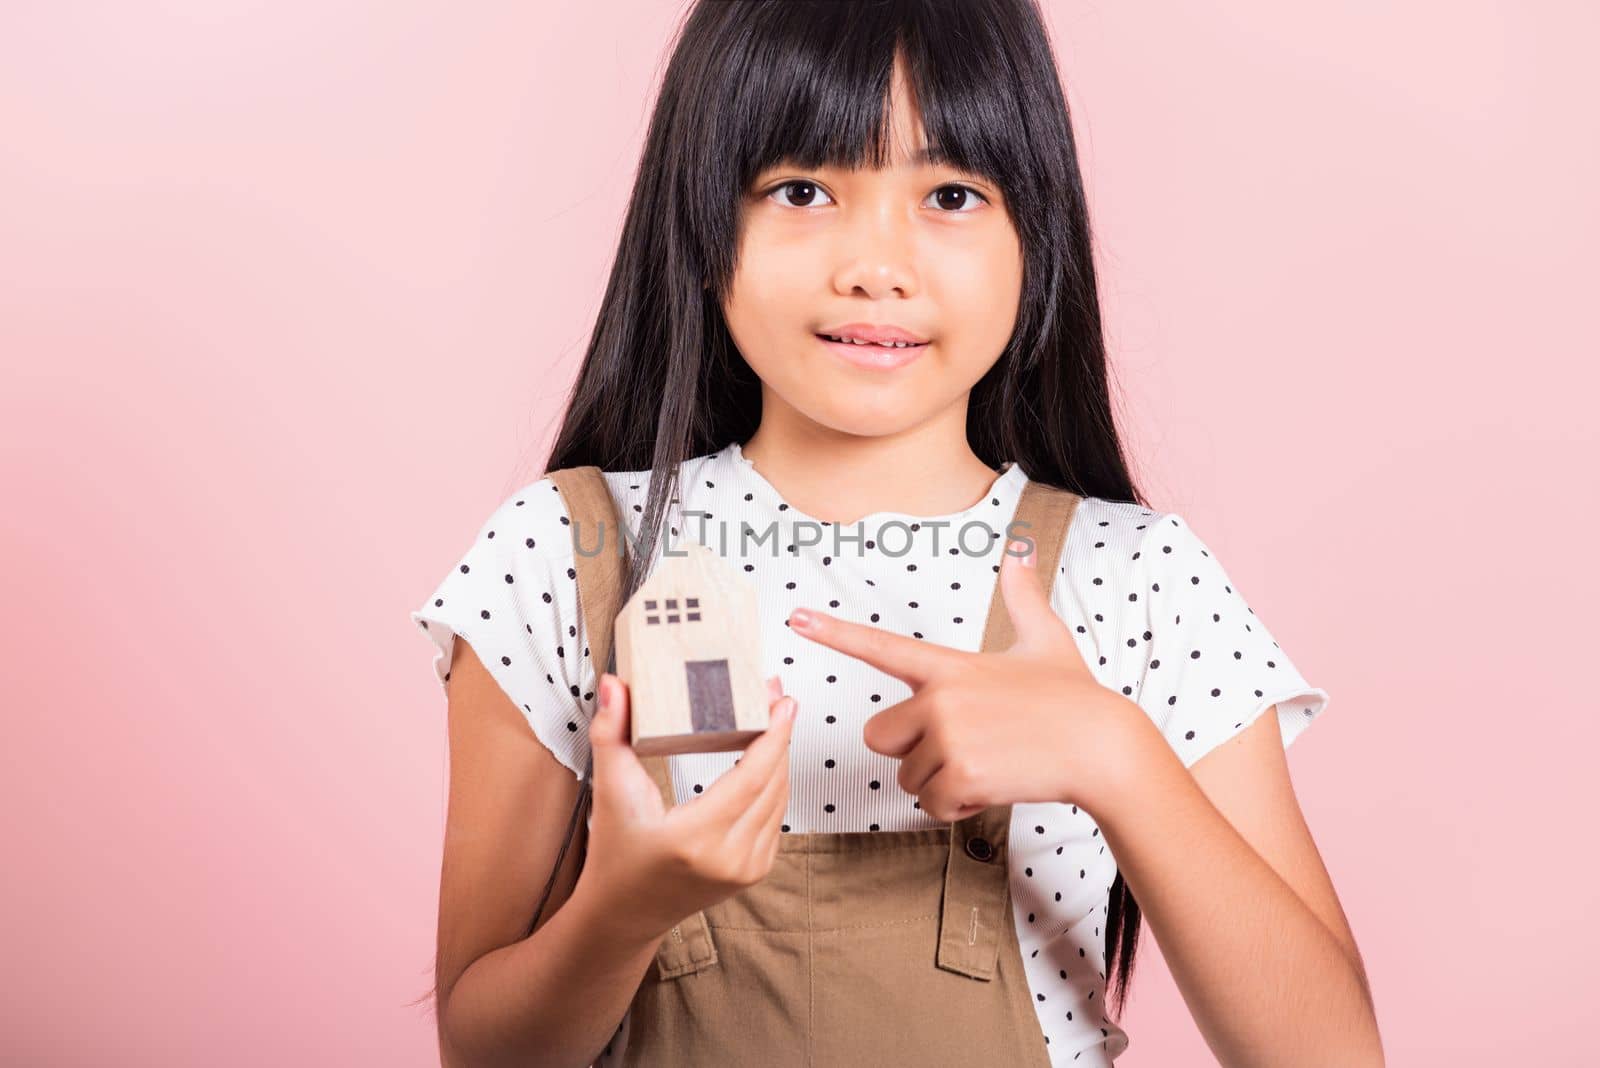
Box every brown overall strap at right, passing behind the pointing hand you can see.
[936,481,1082,980]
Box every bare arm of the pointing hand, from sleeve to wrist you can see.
[1091,705,1384,1066]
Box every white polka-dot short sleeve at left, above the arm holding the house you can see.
[411,478,598,779]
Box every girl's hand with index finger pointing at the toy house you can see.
[789,542,1150,822]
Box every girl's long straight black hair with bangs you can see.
[546,0,1149,1012]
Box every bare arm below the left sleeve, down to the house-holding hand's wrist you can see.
[435,638,661,1068]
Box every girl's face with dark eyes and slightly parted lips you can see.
[723,57,1022,436]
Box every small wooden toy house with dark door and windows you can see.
[614,540,768,756]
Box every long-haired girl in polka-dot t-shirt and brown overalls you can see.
[413,0,1382,1065]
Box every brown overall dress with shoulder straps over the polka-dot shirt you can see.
[552,465,1080,1068]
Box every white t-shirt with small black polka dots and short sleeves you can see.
[411,443,1328,1068]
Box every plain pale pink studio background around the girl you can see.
[0,0,1600,1066]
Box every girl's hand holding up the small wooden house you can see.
[573,673,797,940]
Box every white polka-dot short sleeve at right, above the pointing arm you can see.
[1130,513,1328,767]
